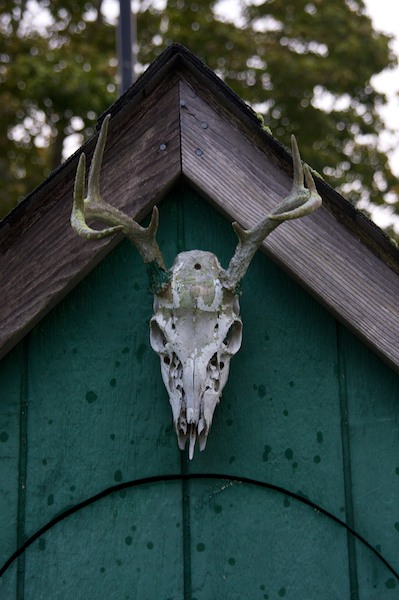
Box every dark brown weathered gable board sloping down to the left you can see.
[0,78,181,356]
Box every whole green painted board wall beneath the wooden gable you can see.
[0,189,399,600]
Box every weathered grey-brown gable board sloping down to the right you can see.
[181,81,399,369]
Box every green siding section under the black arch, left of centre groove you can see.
[22,483,184,600]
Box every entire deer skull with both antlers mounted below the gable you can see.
[71,115,321,459]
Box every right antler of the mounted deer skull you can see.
[223,136,321,290]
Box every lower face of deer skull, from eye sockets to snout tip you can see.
[150,314,242,458]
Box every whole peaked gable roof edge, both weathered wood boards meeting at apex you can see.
[0,44,399,370]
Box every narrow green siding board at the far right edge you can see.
[339,328,399,600]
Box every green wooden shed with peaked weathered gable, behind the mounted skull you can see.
[0,45,399,600]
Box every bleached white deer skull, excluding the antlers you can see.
[150,250,242,458]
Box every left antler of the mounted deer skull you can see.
[71,115,166,272]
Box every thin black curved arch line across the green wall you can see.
[0,473,399,581]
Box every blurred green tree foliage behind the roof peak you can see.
[0,0,399,223]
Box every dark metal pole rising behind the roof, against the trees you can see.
[118,0,136,94]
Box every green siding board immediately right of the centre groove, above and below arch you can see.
[184,194,350,600]
